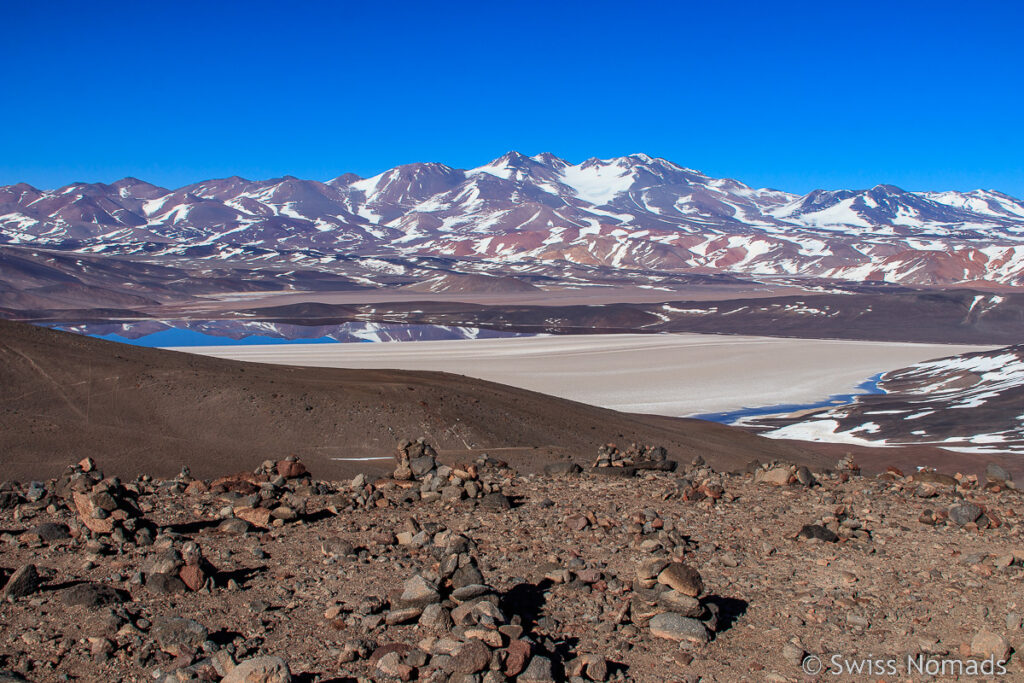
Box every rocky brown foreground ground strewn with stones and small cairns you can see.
[0,439,1024,683]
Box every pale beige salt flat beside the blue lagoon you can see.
[169,334,989,416]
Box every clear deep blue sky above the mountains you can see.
[0,0,1024,197]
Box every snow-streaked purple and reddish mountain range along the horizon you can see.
[0,152,1024,286]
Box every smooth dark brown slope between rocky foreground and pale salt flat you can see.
[0,321,831,479]
